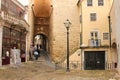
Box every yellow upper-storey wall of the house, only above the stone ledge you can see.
[80,0,110,45]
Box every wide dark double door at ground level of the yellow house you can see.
[84,51,105,70]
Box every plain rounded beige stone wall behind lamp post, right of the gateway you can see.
[49,0,80,62]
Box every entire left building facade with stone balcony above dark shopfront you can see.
[0,0,29,65]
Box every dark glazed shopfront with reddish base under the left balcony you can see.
[2,26,26,65]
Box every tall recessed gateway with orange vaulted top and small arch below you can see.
[30,0,51,57]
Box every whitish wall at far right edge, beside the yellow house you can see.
[110,0,120,72]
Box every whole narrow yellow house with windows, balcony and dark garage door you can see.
[78,0,116,70]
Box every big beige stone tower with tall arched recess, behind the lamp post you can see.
[29,0,80,63]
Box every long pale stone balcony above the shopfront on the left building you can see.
[0,11,28,27]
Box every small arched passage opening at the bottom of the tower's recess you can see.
[33,34,50,61]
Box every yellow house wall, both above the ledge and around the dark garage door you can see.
[76,0,114,63]
